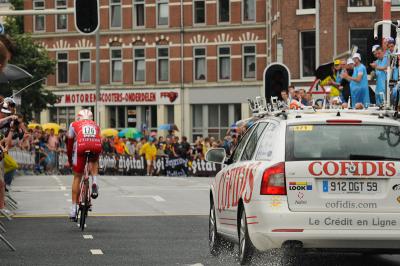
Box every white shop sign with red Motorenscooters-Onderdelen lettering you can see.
[53,89,180,106]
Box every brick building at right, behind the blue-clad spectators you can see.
[267,0,400,94]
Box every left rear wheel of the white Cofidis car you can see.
[239,208,254,265]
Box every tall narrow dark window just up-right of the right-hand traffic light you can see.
[300,31,315,77]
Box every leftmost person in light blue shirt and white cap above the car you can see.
[342,53,370,109]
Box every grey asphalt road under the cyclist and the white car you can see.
[0,176,400,266]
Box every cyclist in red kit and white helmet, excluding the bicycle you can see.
[67,109,102,219]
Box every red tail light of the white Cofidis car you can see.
[260,163,286,195]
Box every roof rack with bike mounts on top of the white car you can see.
[248,96,400,119]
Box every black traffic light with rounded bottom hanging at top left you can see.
[75,0,100,34]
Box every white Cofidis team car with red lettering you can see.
[206,107,400,264]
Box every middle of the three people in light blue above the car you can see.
[370,47,388,106]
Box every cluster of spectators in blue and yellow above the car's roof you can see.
[279,37,400,109]
